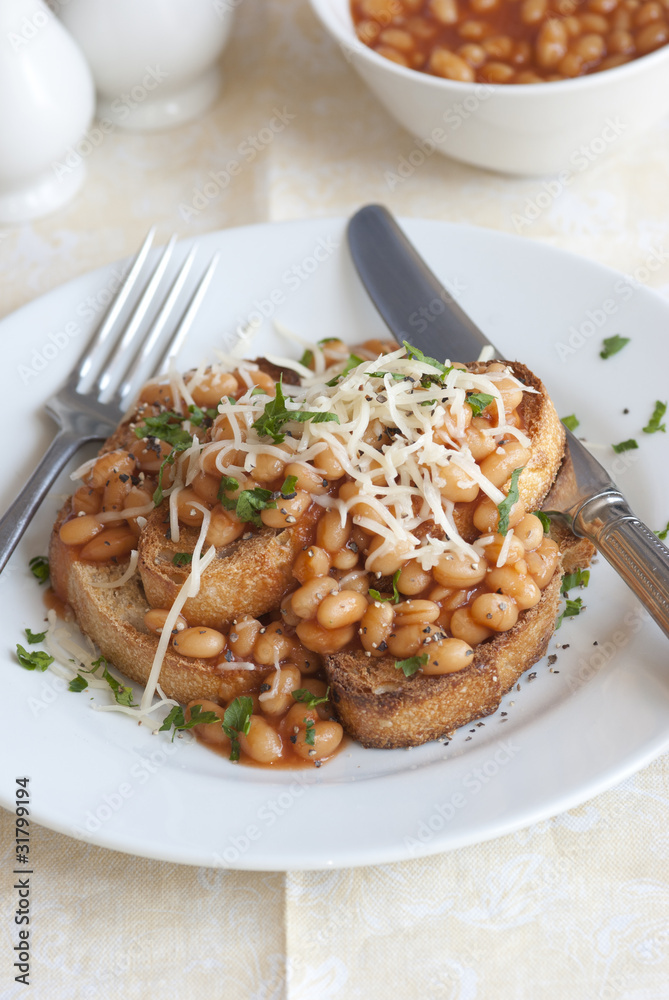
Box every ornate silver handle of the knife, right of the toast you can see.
[572,492,669,637]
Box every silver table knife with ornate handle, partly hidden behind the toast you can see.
[347,205,669,638]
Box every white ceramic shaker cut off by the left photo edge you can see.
[0,0,95,223]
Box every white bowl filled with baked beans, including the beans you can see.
[311,0,669,177]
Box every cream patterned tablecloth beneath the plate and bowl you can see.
[0,0,669,1000]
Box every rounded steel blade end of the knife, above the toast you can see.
[348,205,490,361]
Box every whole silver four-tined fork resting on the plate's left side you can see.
[0,227,219,573]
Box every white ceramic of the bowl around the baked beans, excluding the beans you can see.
[310,0,669,176]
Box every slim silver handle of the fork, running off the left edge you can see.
[0,430,92,573]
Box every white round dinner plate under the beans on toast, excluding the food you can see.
[0,220,669,870]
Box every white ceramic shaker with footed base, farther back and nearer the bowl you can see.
[54,0,241,131]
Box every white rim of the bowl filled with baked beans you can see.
[309,0,669,100]
